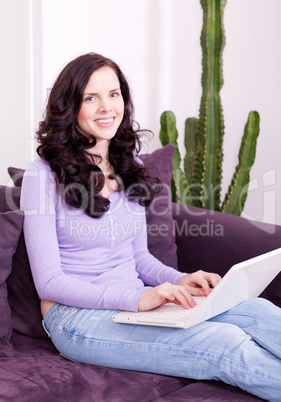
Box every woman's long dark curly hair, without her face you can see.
[36,53,161,218]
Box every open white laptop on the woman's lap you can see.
[112,248,281,328]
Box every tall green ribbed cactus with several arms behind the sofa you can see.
[160,0,259,215]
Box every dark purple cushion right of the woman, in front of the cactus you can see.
[140,144,178,268]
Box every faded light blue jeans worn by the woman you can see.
[43,298,281,401]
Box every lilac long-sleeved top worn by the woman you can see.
[21,158,185,311]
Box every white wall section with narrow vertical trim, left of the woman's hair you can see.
[0,0,42,185]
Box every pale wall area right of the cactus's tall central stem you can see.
[222,0,281,224]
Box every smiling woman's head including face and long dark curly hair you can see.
[37,53,157,217]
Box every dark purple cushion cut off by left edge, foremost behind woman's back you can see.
[0,211,23,357]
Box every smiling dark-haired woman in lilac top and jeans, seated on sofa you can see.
[21,54,281,401]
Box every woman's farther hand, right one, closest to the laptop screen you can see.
[178,270,221,296]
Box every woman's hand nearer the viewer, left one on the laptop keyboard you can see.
[138,282,196,311]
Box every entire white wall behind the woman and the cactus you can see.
[0,0,281,224]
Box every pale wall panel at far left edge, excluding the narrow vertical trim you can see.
[0,1,30,184]
